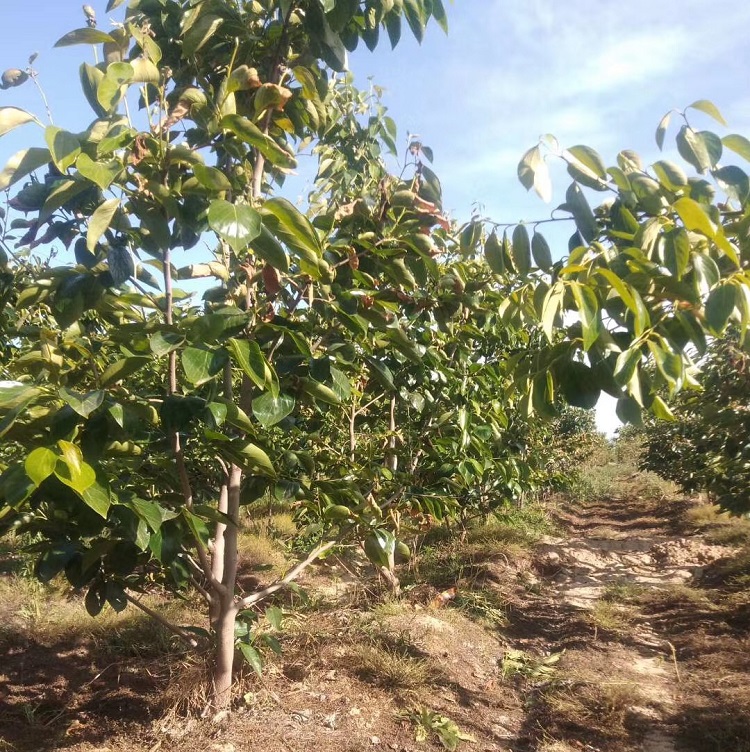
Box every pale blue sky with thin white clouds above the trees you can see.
[0,0,750,433]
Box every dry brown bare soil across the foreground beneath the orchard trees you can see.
[0,490,750,752]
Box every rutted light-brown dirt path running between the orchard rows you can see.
[519,499,727,752]
